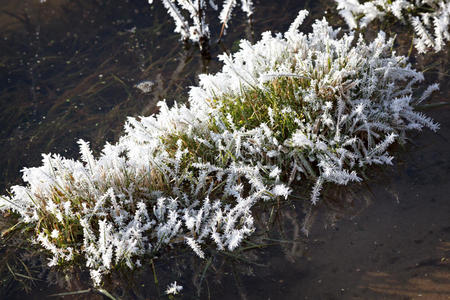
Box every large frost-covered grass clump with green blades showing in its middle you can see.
[0,11,438,288]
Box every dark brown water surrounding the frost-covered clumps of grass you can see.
[0,0,450,299]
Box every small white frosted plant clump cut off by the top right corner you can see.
[335,0,450,53]
